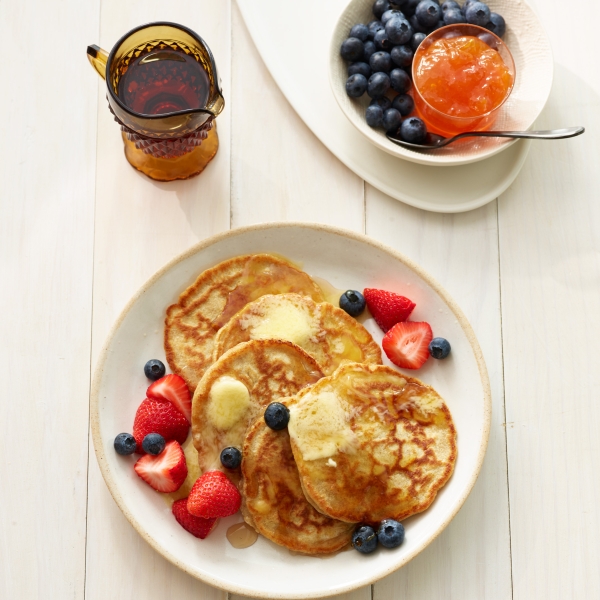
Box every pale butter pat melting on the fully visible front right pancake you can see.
[288,391,356,464]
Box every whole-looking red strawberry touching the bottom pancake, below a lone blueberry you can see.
[187,471,242,519]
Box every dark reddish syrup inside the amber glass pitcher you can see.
[118,48,210,115]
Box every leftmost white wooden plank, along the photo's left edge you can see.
[0,0,99,600]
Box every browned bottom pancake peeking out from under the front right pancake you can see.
[241,415,354,554]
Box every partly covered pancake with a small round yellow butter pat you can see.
[192,340,323,481]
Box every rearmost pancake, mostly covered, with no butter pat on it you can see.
[164,254,324,391]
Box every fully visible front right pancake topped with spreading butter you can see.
[288,364,457,523]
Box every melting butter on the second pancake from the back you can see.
[242,303,316,346]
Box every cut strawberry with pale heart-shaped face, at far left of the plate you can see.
[133,440,187,493]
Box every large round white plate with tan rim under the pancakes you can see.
[91,223,491,598]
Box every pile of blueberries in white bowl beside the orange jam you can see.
[340,0,506,144]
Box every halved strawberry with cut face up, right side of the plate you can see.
[381,321,433,369]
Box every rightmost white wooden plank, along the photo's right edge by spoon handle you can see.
[499,0,600,600]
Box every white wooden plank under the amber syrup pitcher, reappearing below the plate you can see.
[86,0,231,600]
